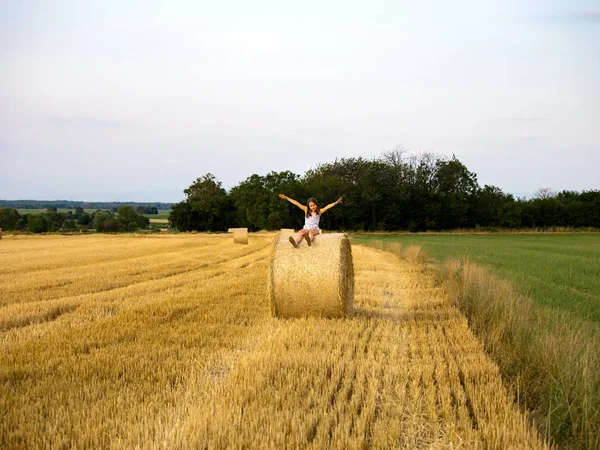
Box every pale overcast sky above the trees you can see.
[0,0,600,201]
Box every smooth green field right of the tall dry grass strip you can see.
[353,233,600,324]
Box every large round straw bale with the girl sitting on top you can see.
[269,233,354,318]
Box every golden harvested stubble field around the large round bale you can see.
[0,234,544,448]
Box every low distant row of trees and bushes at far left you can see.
[0,206,150,233]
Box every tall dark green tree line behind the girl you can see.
[169,149,600,231]
